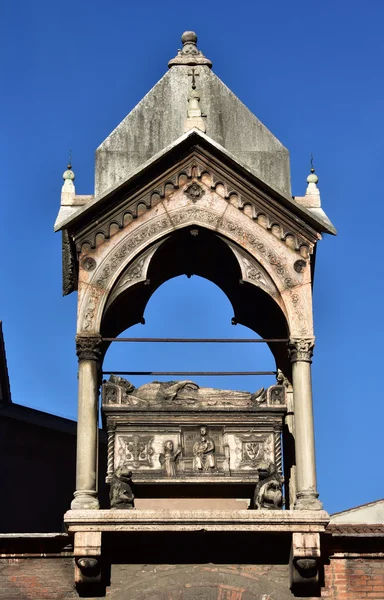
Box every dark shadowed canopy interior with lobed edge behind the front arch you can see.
[100,226,290,373]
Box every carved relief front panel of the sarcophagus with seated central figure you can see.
[110,425,281,479]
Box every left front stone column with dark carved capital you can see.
[71,335,101,510]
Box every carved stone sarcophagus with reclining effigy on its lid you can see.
[102,375,286,508]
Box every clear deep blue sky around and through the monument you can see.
[0,0,384,512]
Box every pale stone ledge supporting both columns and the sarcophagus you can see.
[64,510,329,533]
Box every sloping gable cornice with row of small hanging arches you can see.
[76,147,321,259]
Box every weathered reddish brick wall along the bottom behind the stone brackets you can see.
[0,549,384,600]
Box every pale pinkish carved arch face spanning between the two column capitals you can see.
[78,197,313,335]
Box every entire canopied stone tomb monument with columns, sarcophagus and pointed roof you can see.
[55,32,335,600]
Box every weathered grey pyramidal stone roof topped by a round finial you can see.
[95,32,291,198]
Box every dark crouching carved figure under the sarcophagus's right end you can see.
[251,463,284,510]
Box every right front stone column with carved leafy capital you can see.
[289,338,323,510]
